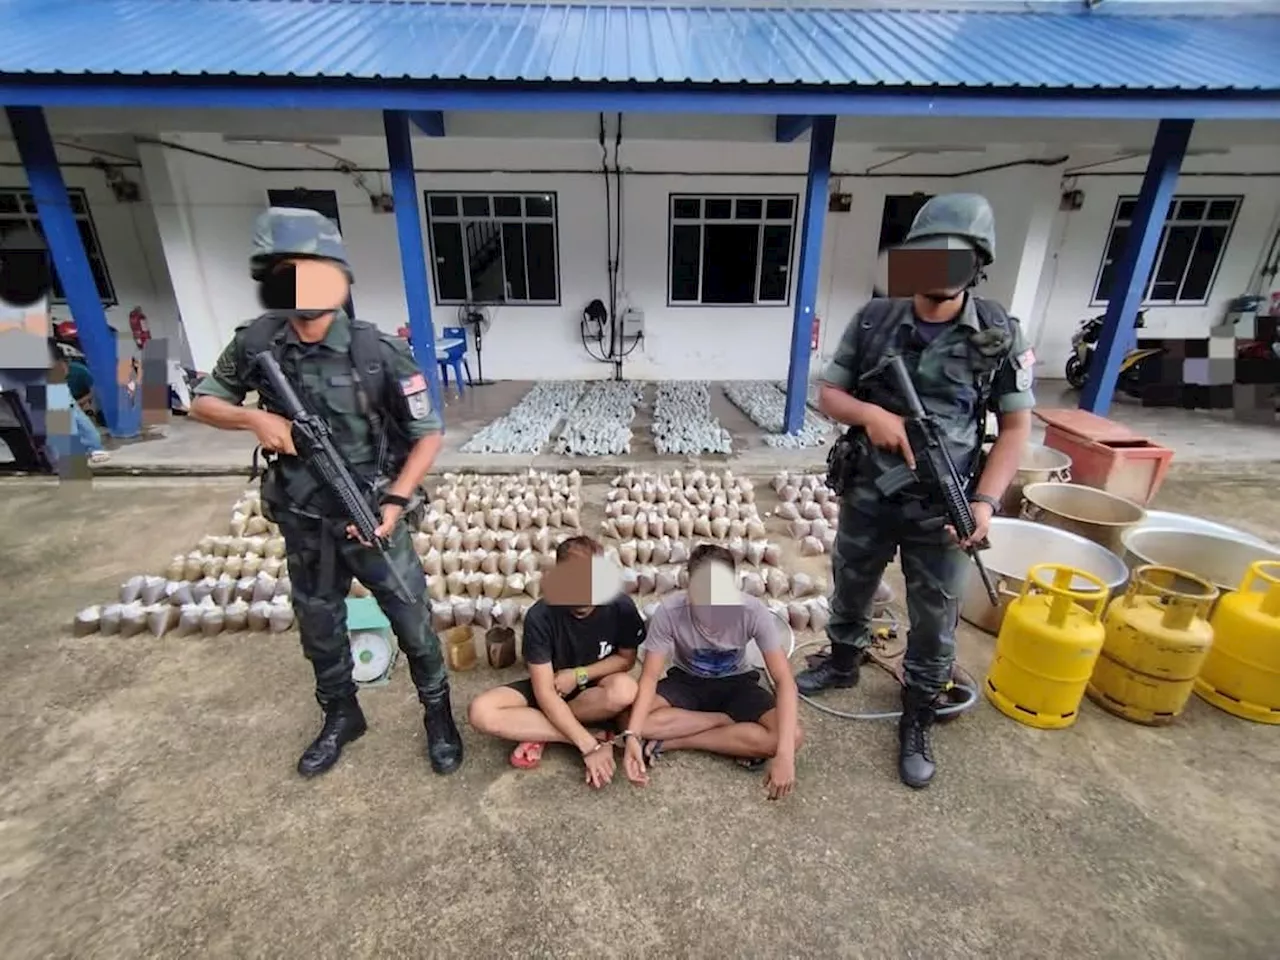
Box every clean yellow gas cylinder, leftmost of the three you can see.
[984,563,1108,730]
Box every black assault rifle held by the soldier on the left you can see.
[257,351,415,603]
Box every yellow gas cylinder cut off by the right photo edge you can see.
[1196,561,1280,723]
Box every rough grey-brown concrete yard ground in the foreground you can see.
[0,468,1280,960]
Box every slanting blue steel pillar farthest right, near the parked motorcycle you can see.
[1080,120,1194,416]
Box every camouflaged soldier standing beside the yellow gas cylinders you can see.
[796,195,1036,787]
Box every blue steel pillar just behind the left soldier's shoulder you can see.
[383,110,444,422]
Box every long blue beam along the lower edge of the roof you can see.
[0,74,1280,120]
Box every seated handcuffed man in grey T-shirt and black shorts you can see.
[622,544,801,800]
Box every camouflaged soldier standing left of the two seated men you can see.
[191,209,462,777]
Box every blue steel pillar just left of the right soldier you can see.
[782,116,836,434]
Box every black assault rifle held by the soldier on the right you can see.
[876,356,1000,607]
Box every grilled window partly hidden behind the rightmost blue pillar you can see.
[1093,197,1243,306]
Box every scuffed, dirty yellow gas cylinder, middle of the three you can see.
[1088,566,1217,726]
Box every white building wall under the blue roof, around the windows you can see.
[10,111,1280,379]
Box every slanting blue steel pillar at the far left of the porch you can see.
[5,106,119,430]
